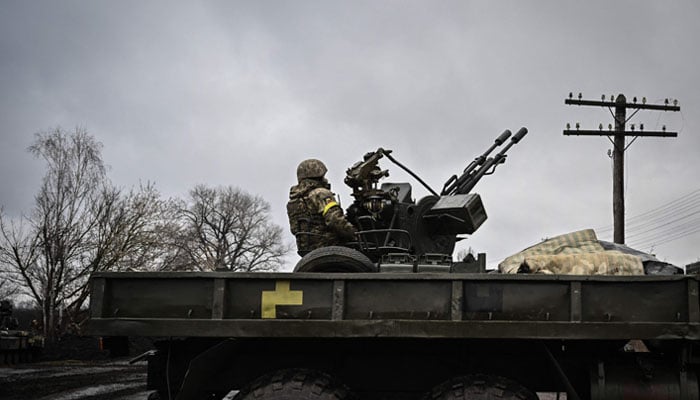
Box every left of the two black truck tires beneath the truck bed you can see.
[233,369,356,400]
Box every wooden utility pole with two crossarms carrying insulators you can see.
[564,93,681,244]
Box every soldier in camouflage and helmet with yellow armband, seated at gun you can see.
[287,159,356,256]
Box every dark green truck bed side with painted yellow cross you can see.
[89,272,700,340]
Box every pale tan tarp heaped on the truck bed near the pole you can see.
[498,229,644,275]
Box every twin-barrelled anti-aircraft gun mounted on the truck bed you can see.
[295,127,527,271]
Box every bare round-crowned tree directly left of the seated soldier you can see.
[175,185,291,271]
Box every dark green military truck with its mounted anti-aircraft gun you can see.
[89,128,700,400]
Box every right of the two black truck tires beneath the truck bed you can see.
[423,374,538,400]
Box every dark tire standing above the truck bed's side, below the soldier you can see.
[294,246,377,272]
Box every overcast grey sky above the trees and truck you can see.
[0,0,700,269]
